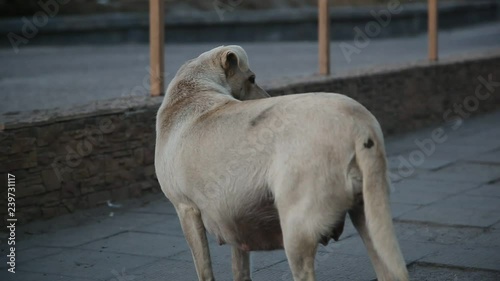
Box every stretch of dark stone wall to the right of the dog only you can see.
[269,51,500,134]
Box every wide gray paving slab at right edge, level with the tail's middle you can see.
[398,202,500,227]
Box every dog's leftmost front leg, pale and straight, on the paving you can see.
[176,203,215,281]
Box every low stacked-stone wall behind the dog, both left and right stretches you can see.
[0,52,500,223]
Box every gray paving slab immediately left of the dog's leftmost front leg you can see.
[79,229,189,258]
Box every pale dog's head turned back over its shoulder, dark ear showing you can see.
[218,45,269,100]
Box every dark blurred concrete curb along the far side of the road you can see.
[0,0,500,46]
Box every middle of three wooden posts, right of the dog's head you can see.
[318,0,330,75]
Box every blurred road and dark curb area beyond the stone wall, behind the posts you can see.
[0,0,500,113]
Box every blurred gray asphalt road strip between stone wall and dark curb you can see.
[0,22,500,114]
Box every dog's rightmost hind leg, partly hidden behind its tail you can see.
[349,205,395,281]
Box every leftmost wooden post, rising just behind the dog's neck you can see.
[149,0,165,96]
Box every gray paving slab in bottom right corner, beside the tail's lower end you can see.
[421,244,500,271]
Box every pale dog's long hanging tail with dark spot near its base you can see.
[356,129,409,281]
